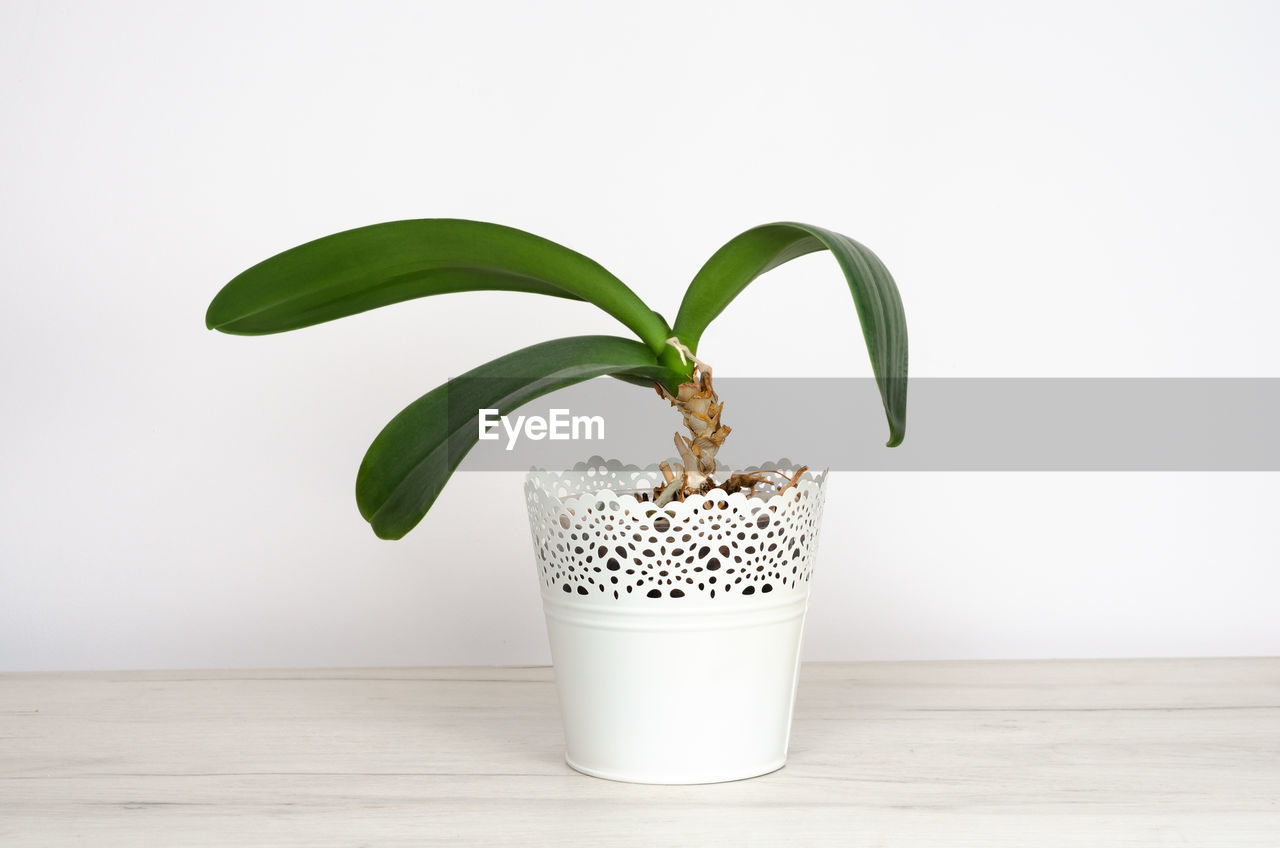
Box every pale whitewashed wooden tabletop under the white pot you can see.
[0,658,1280,848]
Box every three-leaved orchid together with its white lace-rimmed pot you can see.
[206,219,908,783]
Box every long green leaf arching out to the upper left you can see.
[205,218,671,352]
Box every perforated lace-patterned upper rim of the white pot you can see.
[525,457,827,608]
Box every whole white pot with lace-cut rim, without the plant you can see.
[525,459,827,784]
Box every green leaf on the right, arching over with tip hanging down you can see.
[675,222,906,447]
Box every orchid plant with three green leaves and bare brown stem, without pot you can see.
[206,218,908,539]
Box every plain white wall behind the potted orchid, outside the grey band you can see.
[0,1,1280,670]
